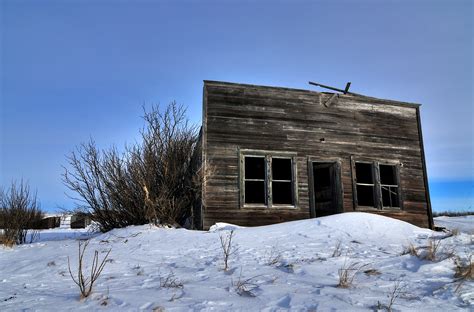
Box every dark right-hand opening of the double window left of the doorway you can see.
[272,158,293,205]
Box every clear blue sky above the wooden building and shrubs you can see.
[0,0,474,211]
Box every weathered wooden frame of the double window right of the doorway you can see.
[351,156,403,211]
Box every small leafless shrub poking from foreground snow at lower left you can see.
[67,241,112,299]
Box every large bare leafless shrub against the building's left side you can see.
[63,102,203,231]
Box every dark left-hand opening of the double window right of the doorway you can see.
[355,163,375,207]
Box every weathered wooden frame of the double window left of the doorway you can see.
[238,149,298,209]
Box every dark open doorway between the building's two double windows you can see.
[312,162,342,217]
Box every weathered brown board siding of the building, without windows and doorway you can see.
[202,81,430,228]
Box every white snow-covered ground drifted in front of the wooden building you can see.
[0,213,474,311]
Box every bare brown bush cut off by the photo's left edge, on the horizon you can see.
[0,180,44,246]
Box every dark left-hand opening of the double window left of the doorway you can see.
[244,156,266,204]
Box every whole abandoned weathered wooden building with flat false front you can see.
[195,81,433,229]
